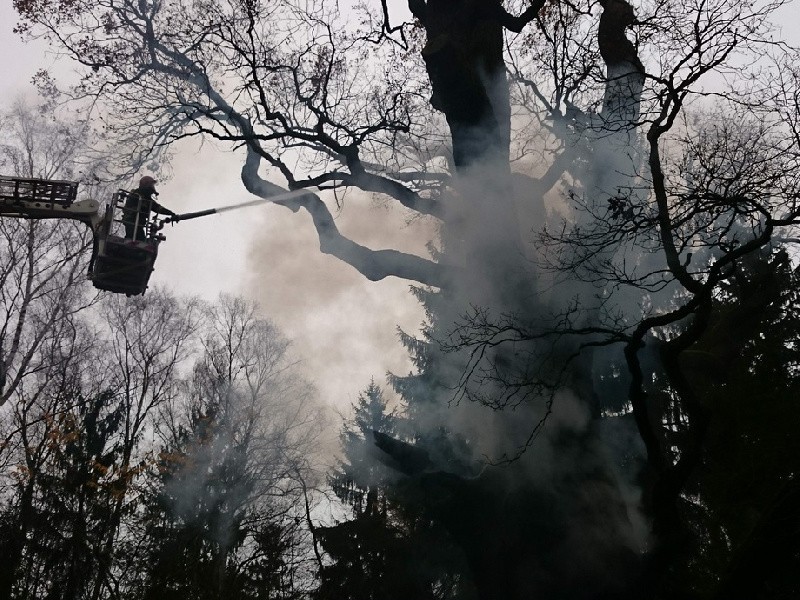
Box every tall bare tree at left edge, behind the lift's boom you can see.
[0,100,102,597]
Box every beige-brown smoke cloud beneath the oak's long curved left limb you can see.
[245,194,436,408]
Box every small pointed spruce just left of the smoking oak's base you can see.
[315,381,464,600]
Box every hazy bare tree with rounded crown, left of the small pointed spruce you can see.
[143,296,320,600]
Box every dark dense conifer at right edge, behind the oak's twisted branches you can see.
[672,250,800,598]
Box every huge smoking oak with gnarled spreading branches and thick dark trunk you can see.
[9,0,798,598]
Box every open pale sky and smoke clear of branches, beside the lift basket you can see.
[0,0,800,409]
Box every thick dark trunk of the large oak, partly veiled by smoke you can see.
[394,0,644,600]
